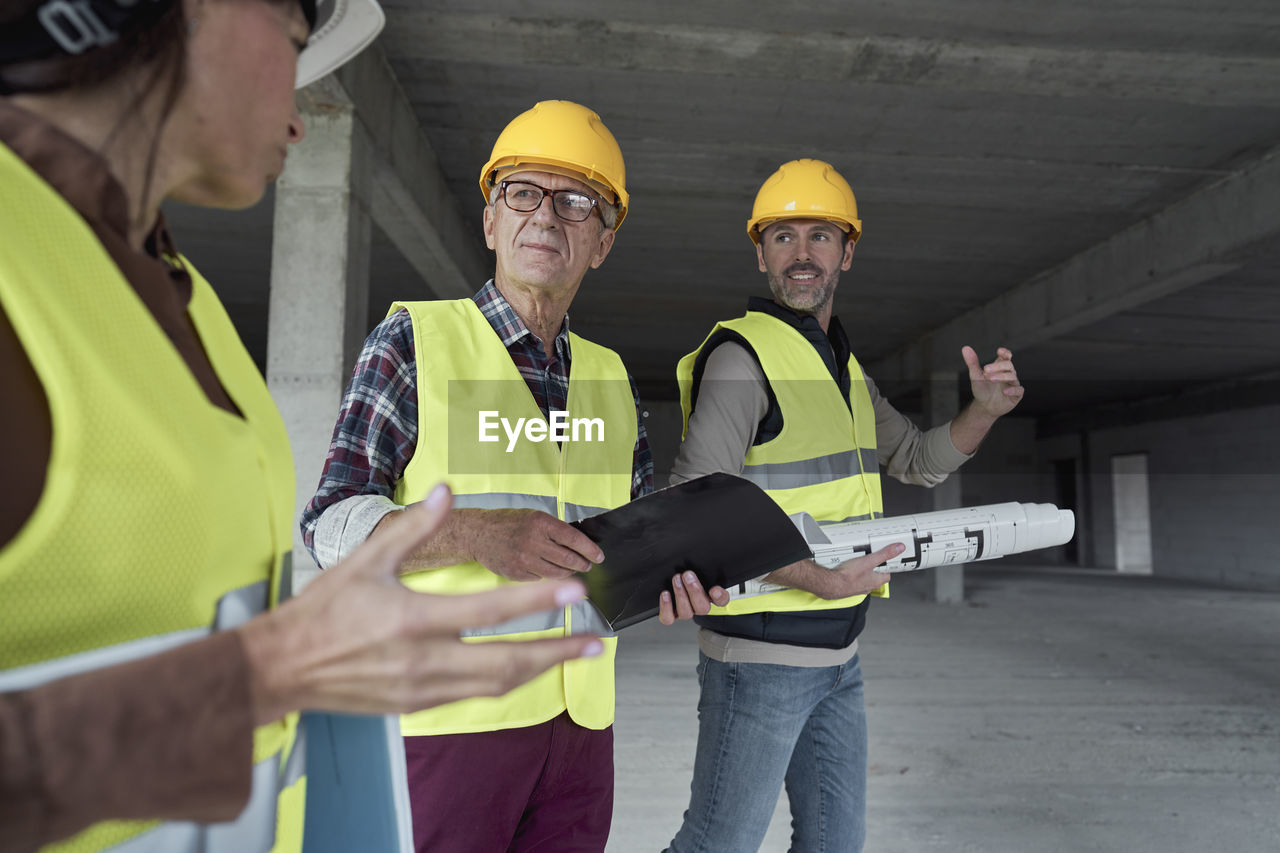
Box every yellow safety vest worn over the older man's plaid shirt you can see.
[390,298,636,735]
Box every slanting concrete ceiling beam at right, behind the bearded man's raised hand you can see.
[870,149,1280,380]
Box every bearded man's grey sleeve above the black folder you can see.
[671,341,769,485]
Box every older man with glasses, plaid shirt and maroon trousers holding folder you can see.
[302,101,728,853]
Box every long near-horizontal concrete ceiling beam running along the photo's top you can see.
[383,9,1280,108]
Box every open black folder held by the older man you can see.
[573,474,813,630]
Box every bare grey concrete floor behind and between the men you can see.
[607,565,1280,853]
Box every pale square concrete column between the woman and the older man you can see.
[266,96,370,573]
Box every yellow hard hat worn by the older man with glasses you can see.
[480,101,630,229]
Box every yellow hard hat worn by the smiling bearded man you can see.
[746,160,863,246]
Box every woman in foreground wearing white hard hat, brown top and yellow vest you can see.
[0,0,602,853]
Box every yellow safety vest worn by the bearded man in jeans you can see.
[676,311,888,616]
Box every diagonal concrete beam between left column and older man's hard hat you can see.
[300,45,492,298]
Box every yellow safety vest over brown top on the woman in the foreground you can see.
[0,145,306,853]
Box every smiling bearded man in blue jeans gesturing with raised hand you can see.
[669,160,1023,853]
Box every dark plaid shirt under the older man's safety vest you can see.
[302,280,653,557]
